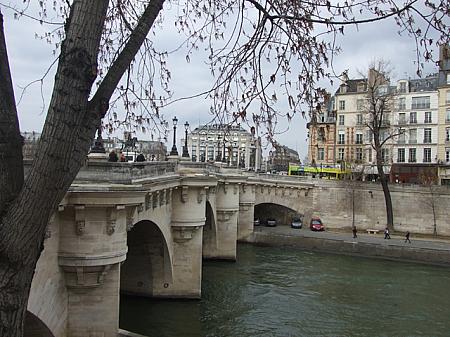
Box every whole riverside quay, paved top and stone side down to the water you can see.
[245,225,450,266]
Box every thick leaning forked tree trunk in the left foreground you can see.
[0,0,164,337]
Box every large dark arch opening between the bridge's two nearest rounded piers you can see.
[120,220,173,297]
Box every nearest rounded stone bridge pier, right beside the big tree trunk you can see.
[59,202,127,337]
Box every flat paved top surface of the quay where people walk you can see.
[254,225,450,251]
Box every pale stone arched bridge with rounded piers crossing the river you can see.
[25,162,314,337]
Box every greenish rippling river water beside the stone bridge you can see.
[120,245,450,337]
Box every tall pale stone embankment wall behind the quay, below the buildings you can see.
[313,180,450,236]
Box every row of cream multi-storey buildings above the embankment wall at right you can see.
[308,45,450,184]
